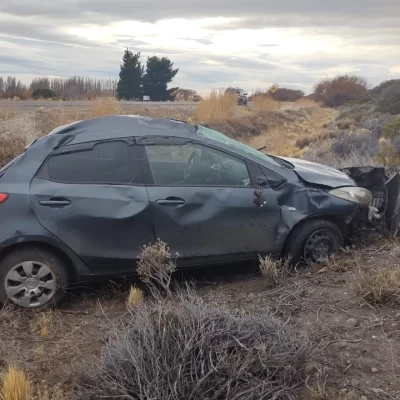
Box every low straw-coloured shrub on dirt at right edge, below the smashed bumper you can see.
[350,268,400,305]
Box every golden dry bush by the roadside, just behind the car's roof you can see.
[194,90,237,122]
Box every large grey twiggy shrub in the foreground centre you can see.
[75,291,311,400]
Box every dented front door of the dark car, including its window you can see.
[138,138,280,265]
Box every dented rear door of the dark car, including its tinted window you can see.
[30,139,155,274]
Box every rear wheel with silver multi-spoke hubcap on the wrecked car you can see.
[0,247,68,309]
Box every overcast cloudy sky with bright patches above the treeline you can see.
[0,0,400,92]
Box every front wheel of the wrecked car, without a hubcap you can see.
[284,220,344,265]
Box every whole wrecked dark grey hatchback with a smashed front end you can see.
[0,116,399,308]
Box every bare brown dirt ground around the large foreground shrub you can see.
[0,240,400,400]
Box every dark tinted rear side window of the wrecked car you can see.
[39,141,140,184]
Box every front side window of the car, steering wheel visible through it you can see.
[145,143,251,186]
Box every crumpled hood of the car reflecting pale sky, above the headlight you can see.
[279,157,356,188]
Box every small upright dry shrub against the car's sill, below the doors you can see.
[137,240,176,294]
